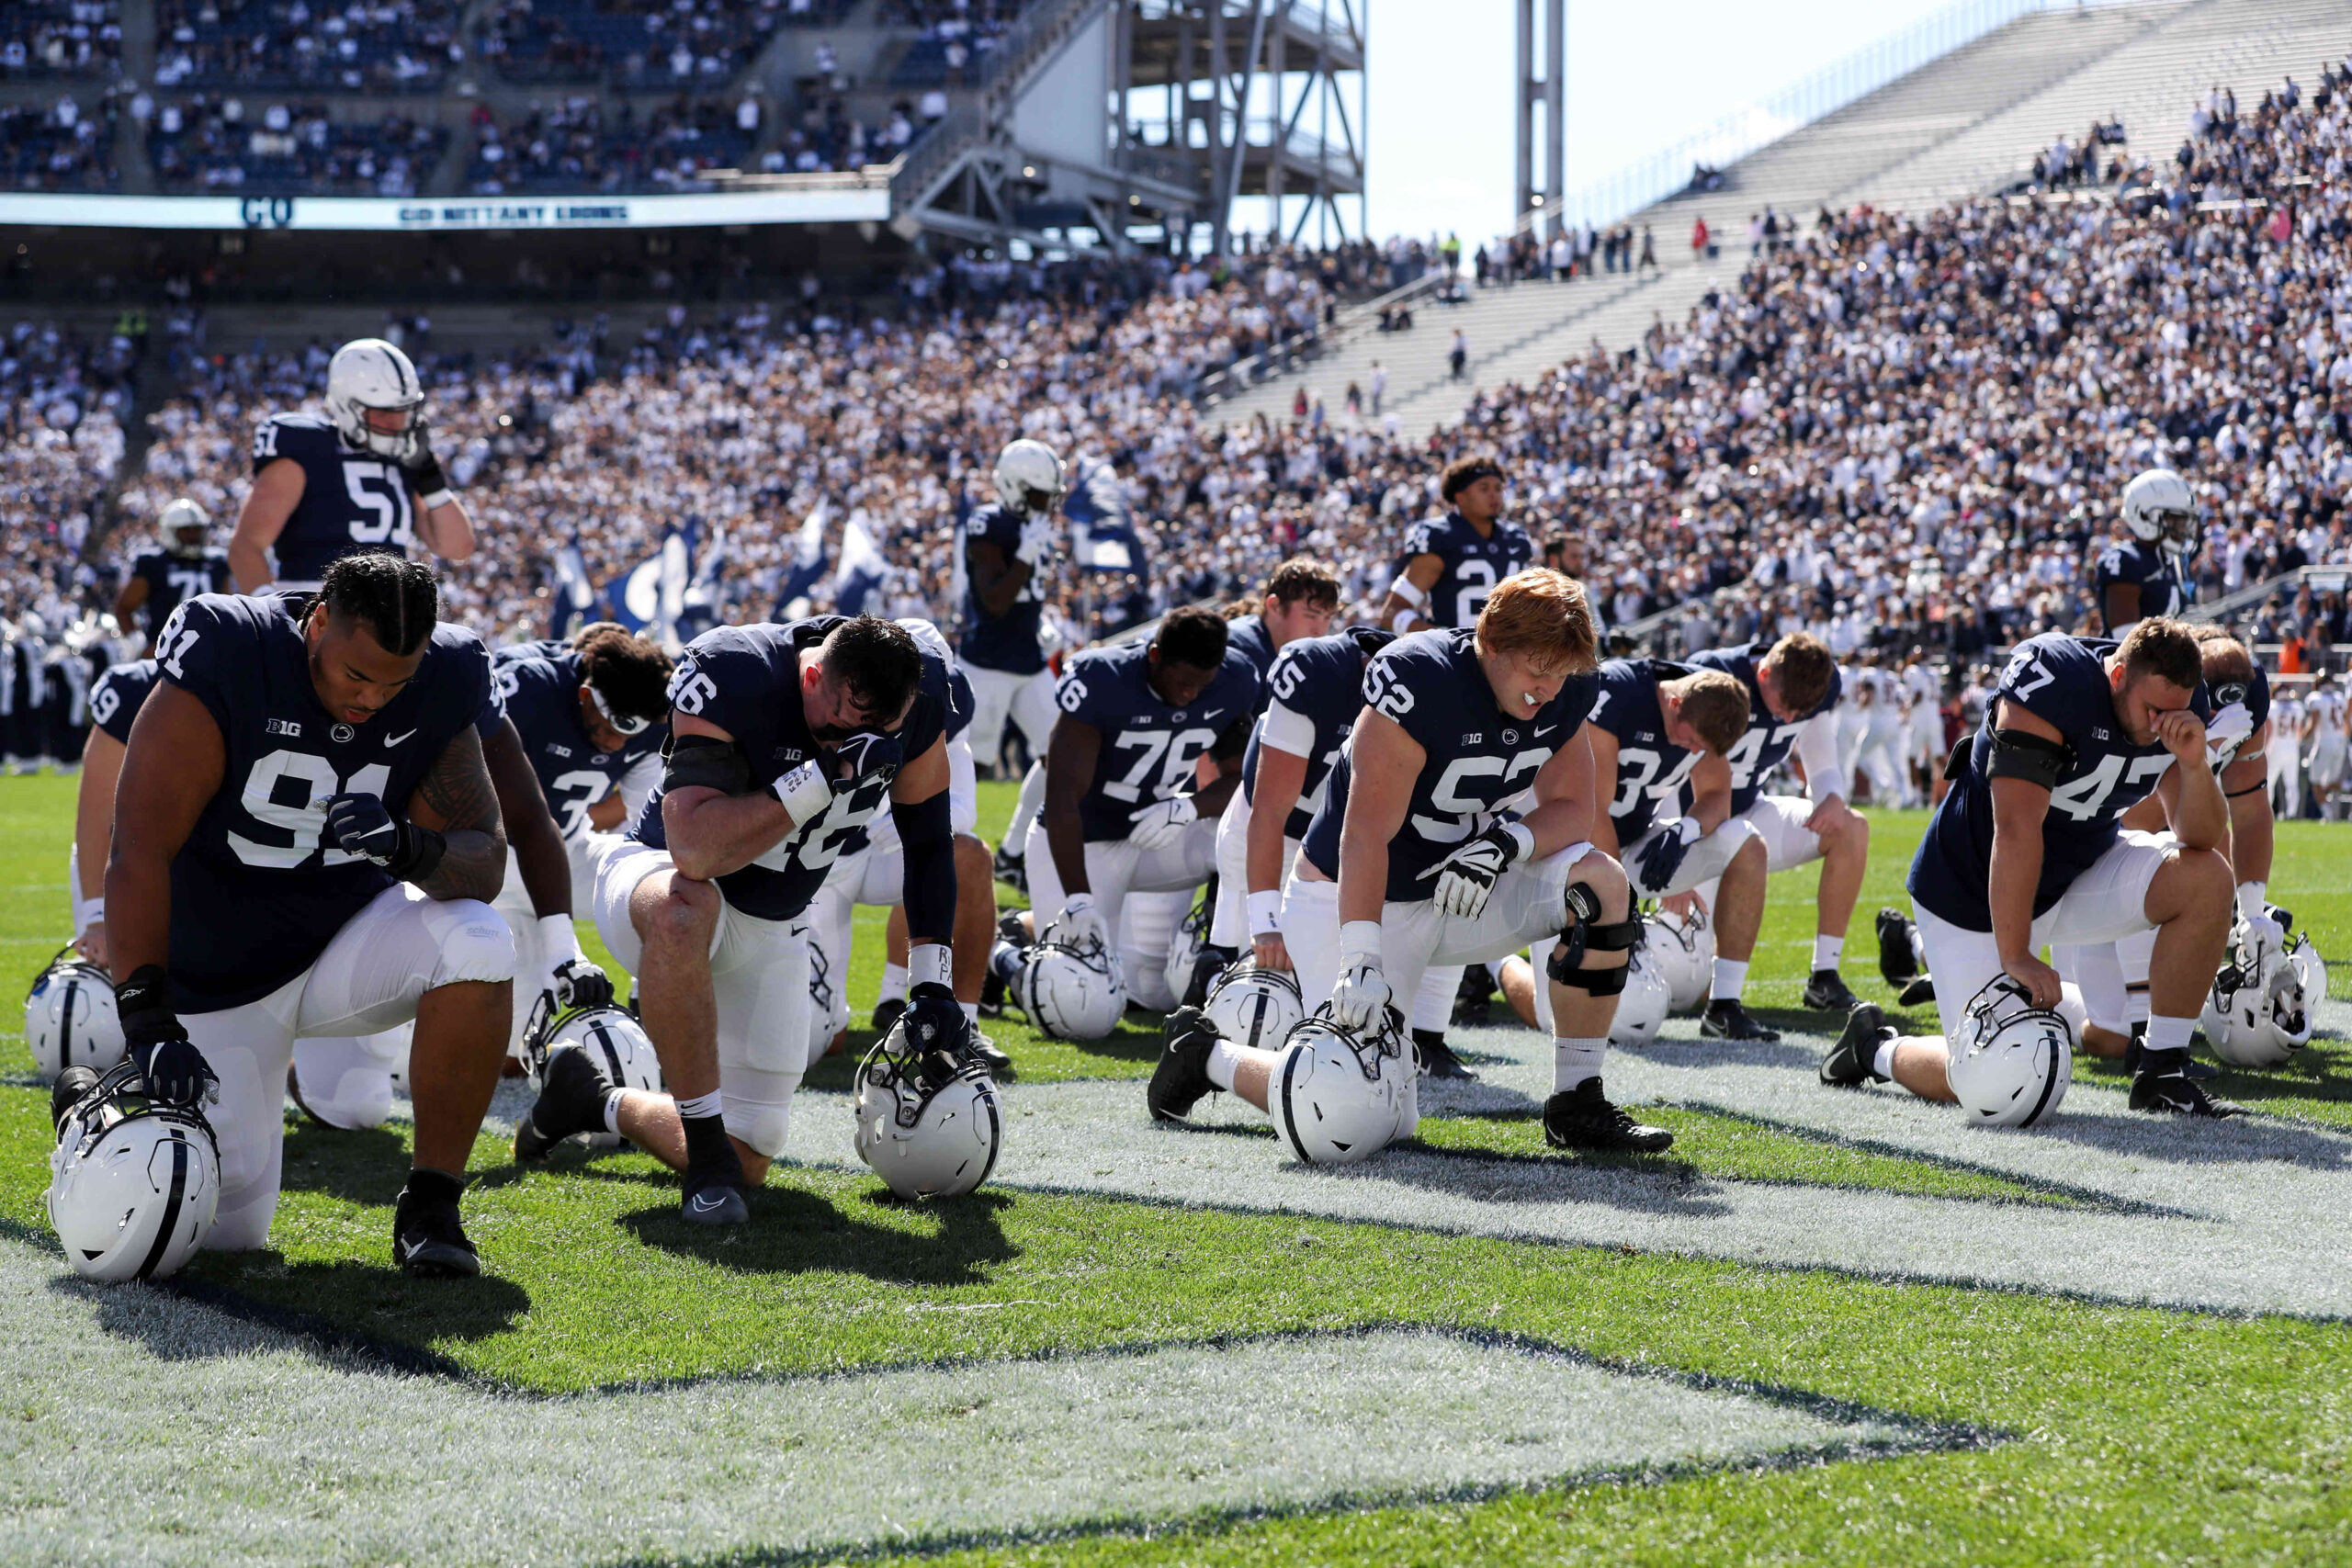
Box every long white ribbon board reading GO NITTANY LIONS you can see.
[0,181,889,232]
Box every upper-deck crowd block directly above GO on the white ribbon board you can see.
[146,94,449,195]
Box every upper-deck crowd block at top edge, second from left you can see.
[155,0,466,92]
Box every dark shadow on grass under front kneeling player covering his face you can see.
[621,1187,1021,1286]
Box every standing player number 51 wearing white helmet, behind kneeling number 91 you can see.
[228,339,473,592]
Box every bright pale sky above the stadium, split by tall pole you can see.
[1326,0,1950,244]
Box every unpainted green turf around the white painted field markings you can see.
[14,778,2352,1565]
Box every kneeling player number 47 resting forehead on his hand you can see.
[1820,618,2237,1117]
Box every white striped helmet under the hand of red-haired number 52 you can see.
[1265,1004,1420,1166]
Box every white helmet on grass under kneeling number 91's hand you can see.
[50,1063,221,1281]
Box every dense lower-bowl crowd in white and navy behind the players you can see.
[14,60,2352,709]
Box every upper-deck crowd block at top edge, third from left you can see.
[482,0,799,87]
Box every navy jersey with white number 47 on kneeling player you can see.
[1910,632,2211,931]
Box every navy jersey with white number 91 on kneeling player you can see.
[155,592,489,1013]
